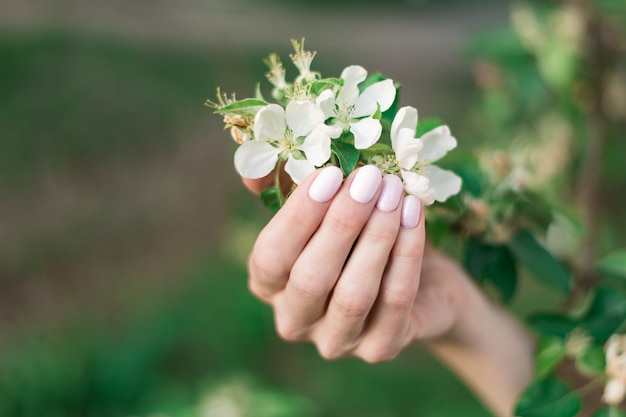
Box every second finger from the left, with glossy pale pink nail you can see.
[274,165,381,338]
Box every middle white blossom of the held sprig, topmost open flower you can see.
[316,65,396,149]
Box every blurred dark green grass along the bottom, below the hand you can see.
[0,254,487,417]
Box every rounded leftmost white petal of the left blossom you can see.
[235,140,280,179]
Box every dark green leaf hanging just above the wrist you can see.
[464,239,517,302]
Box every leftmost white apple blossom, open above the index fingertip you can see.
[235,101,340,184]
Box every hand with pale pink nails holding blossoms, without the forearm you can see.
[245,166,478,362]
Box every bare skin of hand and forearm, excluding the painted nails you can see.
[239,170,534,416]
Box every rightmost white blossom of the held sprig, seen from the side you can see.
[391,106,461,205]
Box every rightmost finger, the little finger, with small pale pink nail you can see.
[355,196,425,362]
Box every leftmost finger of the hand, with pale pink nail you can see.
[248,166,343,301]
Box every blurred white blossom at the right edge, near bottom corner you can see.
[602,334,626,405]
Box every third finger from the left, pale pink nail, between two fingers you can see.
[315,175,403,358]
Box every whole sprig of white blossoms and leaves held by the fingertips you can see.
[207,40,461,208]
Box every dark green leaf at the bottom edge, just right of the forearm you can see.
[515,378,582,417]
